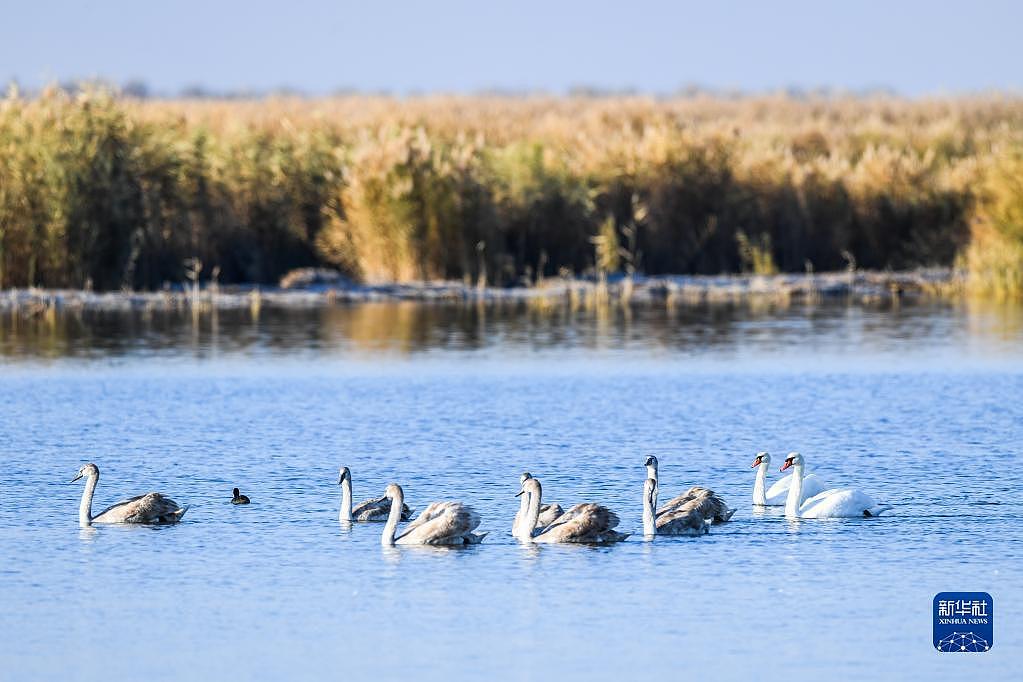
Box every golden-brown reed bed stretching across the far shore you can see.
[6,90,1023,295]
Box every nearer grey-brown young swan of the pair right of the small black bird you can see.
[381,483,487,545]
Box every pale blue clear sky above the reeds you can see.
[0,0,1023,95]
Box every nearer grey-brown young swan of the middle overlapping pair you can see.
[516,479,629,544]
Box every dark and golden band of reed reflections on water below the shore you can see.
[0,301,1023,359]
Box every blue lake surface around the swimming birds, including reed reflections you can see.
[0,304,1023,680]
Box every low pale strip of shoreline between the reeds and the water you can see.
[0,268,965,316]
